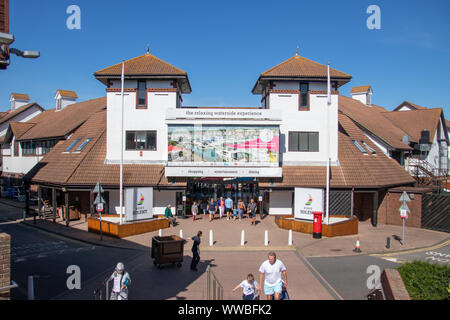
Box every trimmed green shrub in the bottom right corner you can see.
[398,261,450,300]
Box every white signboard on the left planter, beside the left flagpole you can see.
[125,188,153,221]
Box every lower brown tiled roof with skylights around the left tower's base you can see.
[27,111,181,187]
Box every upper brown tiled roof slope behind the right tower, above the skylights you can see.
[339,95,411,150]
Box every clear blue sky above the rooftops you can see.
[0,0,450,118]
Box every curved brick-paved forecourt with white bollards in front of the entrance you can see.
[19,215,450,257]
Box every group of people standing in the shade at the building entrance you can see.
[191,196,258,225]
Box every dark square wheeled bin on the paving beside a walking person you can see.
[152,235,186,269]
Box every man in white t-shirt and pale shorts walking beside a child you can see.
[259,251,287,300]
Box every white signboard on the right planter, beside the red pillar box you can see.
[294,188,324,220]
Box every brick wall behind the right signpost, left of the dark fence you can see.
[378,190,422,228]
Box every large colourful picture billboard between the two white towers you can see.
[168,125,280,167]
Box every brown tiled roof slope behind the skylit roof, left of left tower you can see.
[20,97,106,141]
